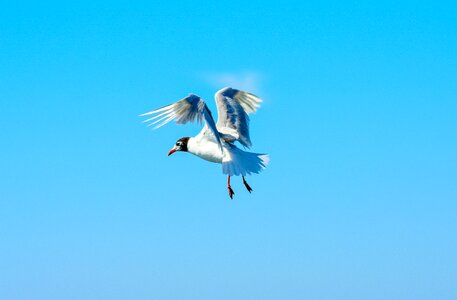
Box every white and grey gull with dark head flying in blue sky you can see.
[140,87,270,199]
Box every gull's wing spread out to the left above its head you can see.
[140,94,222,149]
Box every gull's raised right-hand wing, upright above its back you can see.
[214,87,262,148]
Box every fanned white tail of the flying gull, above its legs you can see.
[222,145,270,176]
